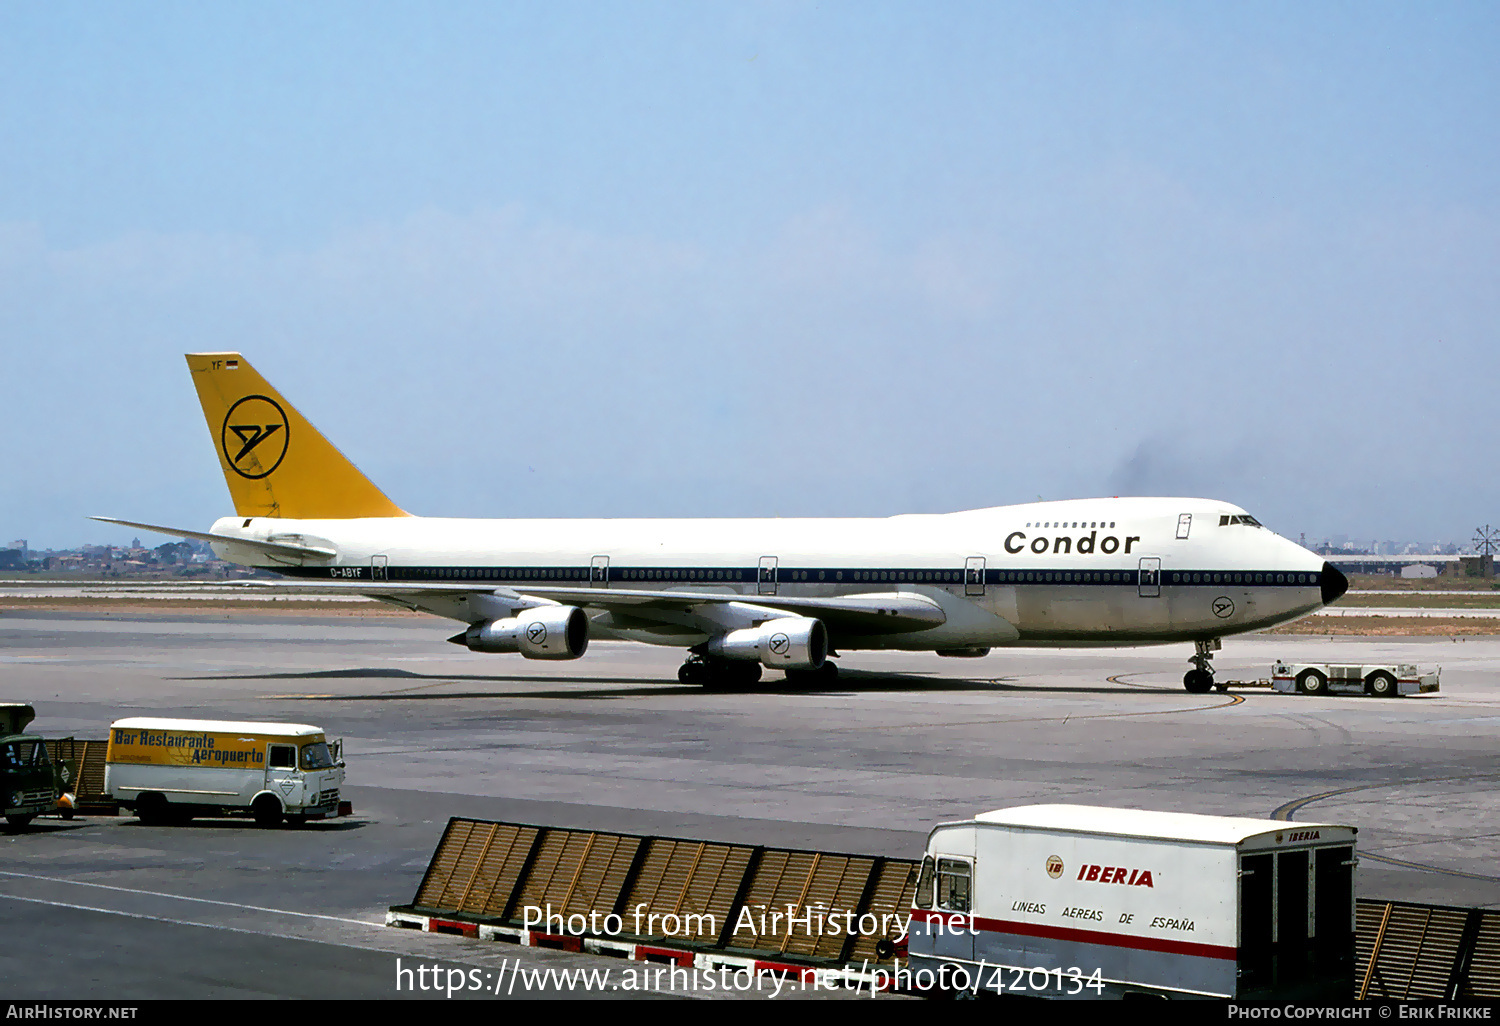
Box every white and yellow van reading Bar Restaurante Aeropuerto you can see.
[104,717,344,827]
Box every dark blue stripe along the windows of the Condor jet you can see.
[270,566,1322,588]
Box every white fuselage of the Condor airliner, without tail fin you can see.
[213,498,1344,651]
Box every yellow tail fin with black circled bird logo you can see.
[188,353,410,519]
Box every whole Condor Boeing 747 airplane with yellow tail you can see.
[95,353,1349,693]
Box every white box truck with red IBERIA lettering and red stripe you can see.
[908,806,1356,1002]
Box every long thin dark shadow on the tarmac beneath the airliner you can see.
[168,666,1200,702]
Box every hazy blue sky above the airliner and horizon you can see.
[0,2,1500,548]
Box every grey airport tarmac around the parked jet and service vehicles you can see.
[0,609,1500,999]
